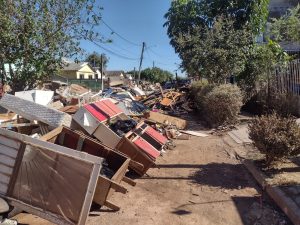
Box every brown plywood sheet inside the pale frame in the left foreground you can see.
[10,146,93,223]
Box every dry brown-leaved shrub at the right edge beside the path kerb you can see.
[249,113,300,166]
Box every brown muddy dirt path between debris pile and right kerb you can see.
[16,133,290,225]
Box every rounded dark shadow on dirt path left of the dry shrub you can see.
[189,163,253,189]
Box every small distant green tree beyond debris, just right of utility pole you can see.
[141,67,173,83]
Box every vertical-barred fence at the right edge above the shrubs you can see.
[275,59,300,96]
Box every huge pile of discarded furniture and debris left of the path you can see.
[0,81,205,224]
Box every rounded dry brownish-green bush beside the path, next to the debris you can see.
[200,84,243,127]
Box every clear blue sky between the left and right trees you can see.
[82,0,180,74]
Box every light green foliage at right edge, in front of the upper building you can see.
[270,4,300,43]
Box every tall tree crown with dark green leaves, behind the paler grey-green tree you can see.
[165,0,269,78]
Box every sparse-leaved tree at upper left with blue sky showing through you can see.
[0,0,103,91]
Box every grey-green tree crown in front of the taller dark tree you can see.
[177,17,251,83]
